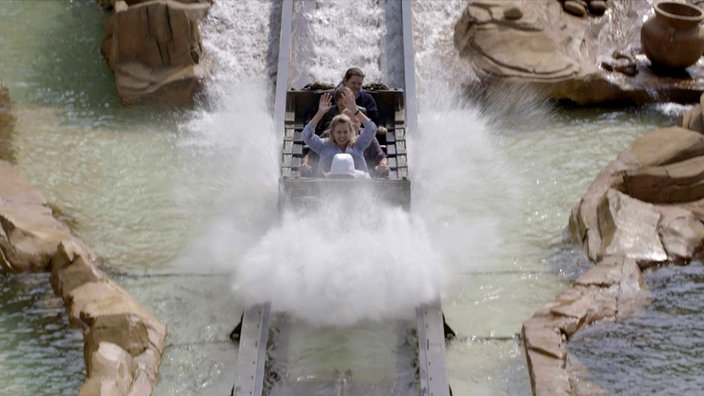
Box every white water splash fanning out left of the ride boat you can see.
[172,83,281,272]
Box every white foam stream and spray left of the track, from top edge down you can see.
[170,1,281,272]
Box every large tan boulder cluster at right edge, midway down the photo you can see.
[569,127,704,265]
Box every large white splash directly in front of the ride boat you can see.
[235,193,445,325]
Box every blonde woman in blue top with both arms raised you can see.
[303,90,376,176]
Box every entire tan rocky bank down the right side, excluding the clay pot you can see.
[454,0,704,395]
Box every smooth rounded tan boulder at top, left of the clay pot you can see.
[454,0,584,81]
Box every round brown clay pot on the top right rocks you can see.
[640,1,704,69]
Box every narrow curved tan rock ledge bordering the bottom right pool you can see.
[521,256,647,396]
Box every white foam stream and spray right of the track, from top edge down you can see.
[408,0,522,280]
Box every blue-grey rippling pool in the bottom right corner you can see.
[569,262,704,395]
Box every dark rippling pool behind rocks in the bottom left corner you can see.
[0,274,85,395]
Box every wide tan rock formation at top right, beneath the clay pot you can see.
[454,0,704,105]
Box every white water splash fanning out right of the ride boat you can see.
[408,87,524,273]
